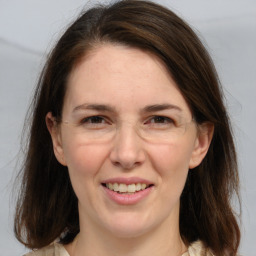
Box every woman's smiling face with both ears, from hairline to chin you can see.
[46,45,210,237]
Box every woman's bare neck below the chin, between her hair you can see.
[66,214,187,256]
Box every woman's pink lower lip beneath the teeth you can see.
[103,186,153,205]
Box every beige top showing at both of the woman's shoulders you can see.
[24,241,214,256]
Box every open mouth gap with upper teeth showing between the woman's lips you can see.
[102,183,153,195]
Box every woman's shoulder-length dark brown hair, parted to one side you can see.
[15,0,240,256]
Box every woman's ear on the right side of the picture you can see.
[189,123,214,169]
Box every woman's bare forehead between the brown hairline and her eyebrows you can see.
[64,44,191,115]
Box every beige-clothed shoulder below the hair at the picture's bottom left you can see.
[24,243,69,256]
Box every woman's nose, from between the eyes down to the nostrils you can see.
[110,126,145,170]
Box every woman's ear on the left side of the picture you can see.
[45,112,67,166]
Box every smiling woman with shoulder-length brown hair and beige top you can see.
[15,0,240,256]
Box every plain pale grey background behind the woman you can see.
[0,0,256,256]
